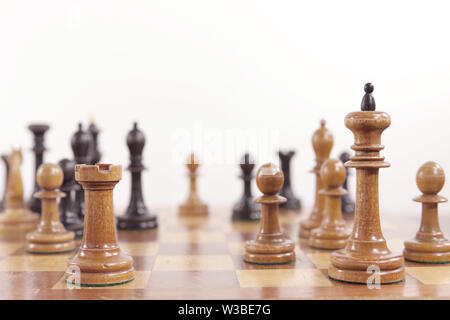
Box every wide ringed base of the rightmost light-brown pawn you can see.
[403,239,450,263]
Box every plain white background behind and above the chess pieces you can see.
[0,0,450,219]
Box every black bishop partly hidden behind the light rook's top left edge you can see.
[70,123,92,220]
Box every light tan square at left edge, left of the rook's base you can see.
[0,254,69,272]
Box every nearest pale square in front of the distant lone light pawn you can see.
[160,230,226,243]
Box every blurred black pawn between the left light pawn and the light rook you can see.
[58,159,83,238]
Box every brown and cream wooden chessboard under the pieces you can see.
[0,209,450,299]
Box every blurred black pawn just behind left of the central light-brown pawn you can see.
[231,152,261,221]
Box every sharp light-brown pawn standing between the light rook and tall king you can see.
[244,163,295,265]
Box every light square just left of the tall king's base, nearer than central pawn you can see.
[236,269,332,288]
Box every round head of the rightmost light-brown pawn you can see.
[416,161,445,194]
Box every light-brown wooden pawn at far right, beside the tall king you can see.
[403,161,450,263]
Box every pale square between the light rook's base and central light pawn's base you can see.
[153,255,234,271]
